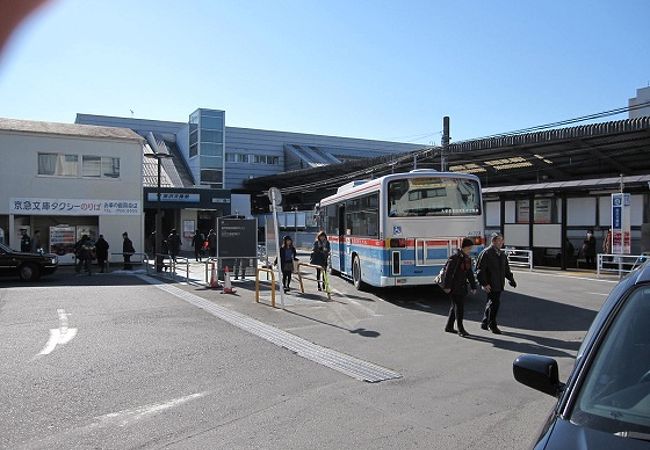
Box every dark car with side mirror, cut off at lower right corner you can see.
[513,263,650,450]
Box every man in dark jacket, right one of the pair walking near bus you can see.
[476,233,517,334]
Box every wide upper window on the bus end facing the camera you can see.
[388,177,481,217]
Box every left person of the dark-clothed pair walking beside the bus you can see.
[442,238,476,337]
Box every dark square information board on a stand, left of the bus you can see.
[217,219,257,258]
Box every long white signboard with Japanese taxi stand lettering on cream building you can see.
[9,197,142,216]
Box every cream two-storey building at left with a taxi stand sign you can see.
[0,119,145,264]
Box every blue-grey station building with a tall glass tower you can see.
[75,109,421,244]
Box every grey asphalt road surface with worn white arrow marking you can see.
[0,273,614,449]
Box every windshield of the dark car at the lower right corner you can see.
[571,286,650,436]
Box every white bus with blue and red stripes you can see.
[319,169,484,289]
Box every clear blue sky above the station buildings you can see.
[0,0,650,144]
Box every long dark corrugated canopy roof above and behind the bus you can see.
[245,117,650,198]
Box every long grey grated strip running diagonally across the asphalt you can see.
[138,275,402,383]
